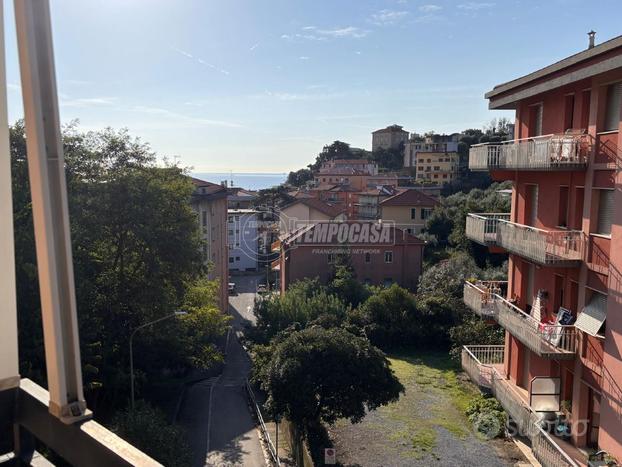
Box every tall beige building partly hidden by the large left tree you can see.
[191,178,229,312]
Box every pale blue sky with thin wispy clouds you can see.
[5,0,622,172]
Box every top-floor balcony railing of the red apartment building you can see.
[469,134,590,170]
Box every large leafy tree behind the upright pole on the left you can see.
[10,122,229,463]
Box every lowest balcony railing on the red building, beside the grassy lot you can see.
[462,345,579,467]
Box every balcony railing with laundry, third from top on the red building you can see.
[494,296,577,360]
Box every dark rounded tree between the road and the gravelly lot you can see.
[262,327,404,427]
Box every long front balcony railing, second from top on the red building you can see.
[494,220,585,266]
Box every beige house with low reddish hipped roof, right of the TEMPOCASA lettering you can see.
[380,189,438,235]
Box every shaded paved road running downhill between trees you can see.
[179,276,266,467]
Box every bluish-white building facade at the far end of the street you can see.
[227,209,260,271]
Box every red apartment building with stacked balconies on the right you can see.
[462,34,622,466]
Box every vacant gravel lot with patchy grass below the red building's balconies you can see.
[330,353,522,467]
